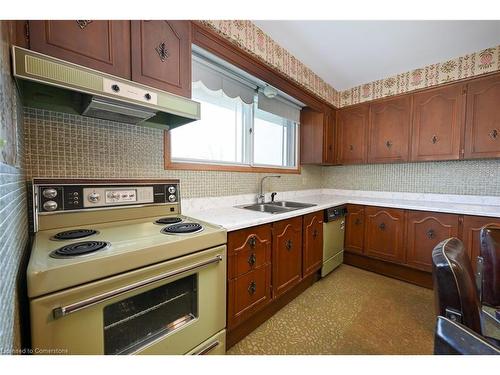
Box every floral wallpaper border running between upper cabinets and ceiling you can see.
[201,20,500,108]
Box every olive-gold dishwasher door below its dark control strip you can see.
[321,216,345,277]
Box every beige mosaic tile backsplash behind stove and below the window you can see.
[24,108,322,198]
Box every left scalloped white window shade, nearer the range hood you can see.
[192,54,257,104]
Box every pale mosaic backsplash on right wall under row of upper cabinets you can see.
[323,159,500,196]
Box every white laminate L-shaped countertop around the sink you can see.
[182,189,500,232]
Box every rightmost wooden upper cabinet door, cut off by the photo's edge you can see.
[465,75,500,159]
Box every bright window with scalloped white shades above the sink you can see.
[169,50,300,171]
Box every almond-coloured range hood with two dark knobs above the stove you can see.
[12,46,200,129]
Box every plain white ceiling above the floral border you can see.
[253,20,500,91]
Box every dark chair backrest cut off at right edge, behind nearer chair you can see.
[478,227,500,308]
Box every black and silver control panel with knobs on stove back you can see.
[34,180,180,213]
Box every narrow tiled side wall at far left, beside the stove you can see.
[0,21,28,354]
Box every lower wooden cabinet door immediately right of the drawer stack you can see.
[272,217,302,297]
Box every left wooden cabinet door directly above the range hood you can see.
[29,20,131,79]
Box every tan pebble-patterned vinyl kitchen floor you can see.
[227,265,435,354]
